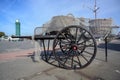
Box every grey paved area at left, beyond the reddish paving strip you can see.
[0,40,34,54]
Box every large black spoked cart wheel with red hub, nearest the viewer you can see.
[53,26,97,69]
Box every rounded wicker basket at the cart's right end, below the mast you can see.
[89,18,113,35]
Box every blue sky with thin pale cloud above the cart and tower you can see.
[0,0,120,35]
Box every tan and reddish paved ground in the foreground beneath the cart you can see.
[0,40,120,80]
